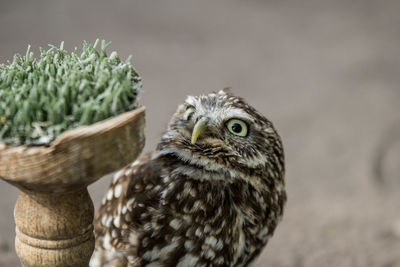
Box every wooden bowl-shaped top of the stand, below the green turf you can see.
[0,107,145,193]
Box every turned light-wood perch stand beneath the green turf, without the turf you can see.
[0,107,145,267]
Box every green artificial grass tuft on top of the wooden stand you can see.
[0,40,142,145]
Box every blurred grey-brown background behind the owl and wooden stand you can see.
[0,0,400,267]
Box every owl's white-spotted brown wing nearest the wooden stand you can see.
[90,153,162,267]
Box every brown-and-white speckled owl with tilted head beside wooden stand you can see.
[90,89,286,267]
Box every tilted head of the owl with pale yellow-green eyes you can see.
[158,89,284,184]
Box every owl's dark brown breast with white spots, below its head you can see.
[128,150,284,266]
